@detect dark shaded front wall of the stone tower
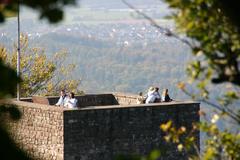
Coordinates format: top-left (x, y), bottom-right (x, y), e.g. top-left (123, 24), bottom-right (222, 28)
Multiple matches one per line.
top-left (64, 103), bottom-right (199, 160)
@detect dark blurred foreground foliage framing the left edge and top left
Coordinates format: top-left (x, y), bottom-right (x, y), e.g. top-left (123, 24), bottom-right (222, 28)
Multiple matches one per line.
top-left (0, 0), bottom-right (75, 160)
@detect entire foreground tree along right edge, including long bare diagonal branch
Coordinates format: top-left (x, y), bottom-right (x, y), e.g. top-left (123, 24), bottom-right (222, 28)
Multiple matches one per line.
top-left (122, 0), bottom-right (240, 160)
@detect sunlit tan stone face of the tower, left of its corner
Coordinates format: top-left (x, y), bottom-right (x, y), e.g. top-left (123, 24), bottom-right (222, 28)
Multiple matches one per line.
top-left (4, 101), bottom-right (63, 160)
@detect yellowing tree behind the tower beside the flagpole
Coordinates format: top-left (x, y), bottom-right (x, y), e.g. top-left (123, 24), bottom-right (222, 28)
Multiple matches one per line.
top-left (0, 35), bottom-right (80, 97)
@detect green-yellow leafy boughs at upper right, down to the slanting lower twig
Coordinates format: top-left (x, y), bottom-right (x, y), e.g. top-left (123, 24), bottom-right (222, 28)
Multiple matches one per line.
top-left (162, 0), bottom-right (240, 123)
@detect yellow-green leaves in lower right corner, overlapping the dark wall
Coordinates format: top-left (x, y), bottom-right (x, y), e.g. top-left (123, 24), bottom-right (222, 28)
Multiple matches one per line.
top-left (158, 112), bottom-right (240, 160)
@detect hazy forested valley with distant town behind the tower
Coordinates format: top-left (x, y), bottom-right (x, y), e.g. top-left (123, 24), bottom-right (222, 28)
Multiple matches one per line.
top-left (0, 0), bottom-right (191, 98)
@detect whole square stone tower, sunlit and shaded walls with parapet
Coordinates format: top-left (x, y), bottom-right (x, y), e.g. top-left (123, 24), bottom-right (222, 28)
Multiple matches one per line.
top-left (3, 93), bottom-right (199, 160)
